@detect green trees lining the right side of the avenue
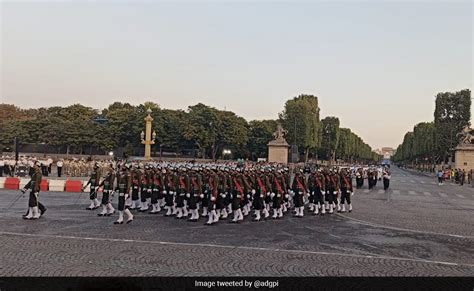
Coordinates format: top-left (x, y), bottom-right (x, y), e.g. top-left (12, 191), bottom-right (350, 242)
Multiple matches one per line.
top-left (393, 89), bottom-right (471, 165)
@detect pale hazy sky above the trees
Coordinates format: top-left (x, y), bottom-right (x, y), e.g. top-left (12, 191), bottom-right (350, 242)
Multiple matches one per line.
top-left (0, 1), bottom-right (474, 149)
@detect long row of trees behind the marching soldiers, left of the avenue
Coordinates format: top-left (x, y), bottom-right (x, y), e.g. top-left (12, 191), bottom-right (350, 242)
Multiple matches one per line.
top-left (0, 95), bottom-right (380, 162)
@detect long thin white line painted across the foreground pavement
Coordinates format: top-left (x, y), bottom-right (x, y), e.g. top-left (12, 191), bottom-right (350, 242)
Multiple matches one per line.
top-left (0, 233), bottom-right (474, 267)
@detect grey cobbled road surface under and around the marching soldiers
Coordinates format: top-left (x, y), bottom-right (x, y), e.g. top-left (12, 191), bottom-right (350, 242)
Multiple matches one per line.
top-left (0, 168), bottom-right (474, 276)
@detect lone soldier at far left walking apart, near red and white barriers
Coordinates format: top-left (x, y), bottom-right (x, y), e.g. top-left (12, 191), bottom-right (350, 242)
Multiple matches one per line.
top-left (21, 162), bottom-right (46, 220)
